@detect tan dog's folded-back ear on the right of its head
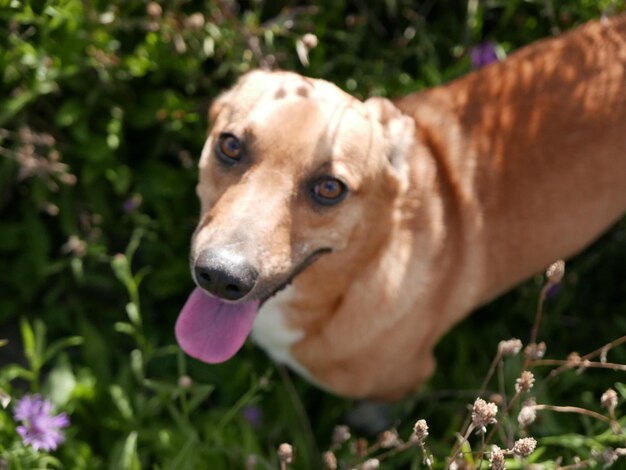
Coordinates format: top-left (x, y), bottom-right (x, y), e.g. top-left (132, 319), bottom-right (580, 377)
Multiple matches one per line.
top-left (365, 98), bottom-right (415, 171)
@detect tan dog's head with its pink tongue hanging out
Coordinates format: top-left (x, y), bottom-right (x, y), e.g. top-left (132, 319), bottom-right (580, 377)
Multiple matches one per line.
top-left (176, 71), bottom-right (414, 362)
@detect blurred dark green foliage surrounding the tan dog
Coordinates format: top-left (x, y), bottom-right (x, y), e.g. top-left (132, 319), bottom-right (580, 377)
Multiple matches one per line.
top-left (0, 0), bottom-right (626, 469)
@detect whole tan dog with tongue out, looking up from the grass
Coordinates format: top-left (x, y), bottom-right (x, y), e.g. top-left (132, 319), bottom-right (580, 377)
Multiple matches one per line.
top-left (176, 16), bottom-right (626, 398)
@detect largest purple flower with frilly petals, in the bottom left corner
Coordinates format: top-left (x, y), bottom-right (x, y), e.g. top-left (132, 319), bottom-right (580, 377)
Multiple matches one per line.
top-left (13, 394), bottom-right (70, 451)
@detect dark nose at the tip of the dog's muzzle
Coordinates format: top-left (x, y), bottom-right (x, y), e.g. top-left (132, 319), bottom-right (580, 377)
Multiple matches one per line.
top-left (194, 250), bottom-right (259, 300)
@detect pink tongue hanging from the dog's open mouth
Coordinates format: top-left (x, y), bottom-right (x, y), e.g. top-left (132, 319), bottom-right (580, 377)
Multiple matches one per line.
top-left (176, 287), bottom-right (259, 364)
